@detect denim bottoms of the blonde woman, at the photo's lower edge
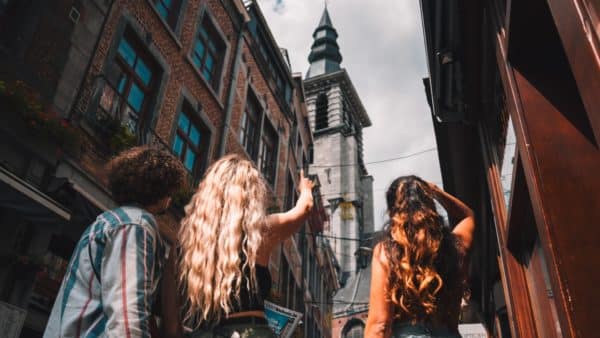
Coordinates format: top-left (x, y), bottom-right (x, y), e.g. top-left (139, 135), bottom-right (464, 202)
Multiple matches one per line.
top-left (189, 320), bottom-right (276, 338)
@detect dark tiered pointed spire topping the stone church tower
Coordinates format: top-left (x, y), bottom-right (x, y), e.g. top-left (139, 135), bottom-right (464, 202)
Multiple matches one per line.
top-left (306, 3), bottom-right (342, 78)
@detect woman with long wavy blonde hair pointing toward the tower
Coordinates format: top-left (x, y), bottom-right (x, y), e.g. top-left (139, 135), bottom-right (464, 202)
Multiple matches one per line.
top-left (178, 155), bottom-right (313, 337)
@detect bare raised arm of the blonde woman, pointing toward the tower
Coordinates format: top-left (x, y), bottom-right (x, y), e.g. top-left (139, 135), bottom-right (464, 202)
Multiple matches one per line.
top-left (267, 170), bottom-right (314, 244)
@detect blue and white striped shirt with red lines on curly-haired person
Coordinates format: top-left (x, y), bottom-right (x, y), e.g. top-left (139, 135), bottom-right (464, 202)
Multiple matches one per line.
top-left (44, 206), bottom-right (168, 338)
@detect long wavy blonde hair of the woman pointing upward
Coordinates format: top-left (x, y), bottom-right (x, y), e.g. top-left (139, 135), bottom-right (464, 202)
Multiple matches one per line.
top-left (179, 155), bottom-right (267, 328)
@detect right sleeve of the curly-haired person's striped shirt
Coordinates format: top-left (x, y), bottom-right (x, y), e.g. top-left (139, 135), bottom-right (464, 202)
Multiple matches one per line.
top-left (101, 224), bottom-right (160, 337)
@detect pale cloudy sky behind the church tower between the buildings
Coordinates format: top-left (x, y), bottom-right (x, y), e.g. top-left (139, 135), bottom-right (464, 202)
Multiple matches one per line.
top-left (258, 0), bottom-right (441, 229)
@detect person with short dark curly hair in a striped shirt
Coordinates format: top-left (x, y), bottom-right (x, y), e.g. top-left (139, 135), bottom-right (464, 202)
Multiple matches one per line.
top-left (44, 147), bottom-right (185, 337)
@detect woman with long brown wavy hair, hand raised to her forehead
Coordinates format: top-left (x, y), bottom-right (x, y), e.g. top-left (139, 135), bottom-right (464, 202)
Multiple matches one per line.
top-left (365, 176), bottom-right (475, 338)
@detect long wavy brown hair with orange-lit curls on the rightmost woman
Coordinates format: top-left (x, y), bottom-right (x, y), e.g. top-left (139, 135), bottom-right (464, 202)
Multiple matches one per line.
top-left (383, 176), bottom-right (461, 322)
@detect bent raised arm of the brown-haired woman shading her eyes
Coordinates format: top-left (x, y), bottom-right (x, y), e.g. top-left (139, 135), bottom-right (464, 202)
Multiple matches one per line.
top-left (429, 183), bottom-right (475, 251)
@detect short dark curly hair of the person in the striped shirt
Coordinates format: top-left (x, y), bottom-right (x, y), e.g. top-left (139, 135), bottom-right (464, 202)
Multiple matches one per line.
top-left (107, 146), bottom-right (186, 206)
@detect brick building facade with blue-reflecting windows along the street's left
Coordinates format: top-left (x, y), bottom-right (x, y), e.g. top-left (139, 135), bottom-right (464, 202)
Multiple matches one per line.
top-left (0, 0), bottom-right (336, 337)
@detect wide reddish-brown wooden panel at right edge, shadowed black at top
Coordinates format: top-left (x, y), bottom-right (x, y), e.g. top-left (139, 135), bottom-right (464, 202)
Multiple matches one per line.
top-left (508, 0), bottom-right (600, 337)
